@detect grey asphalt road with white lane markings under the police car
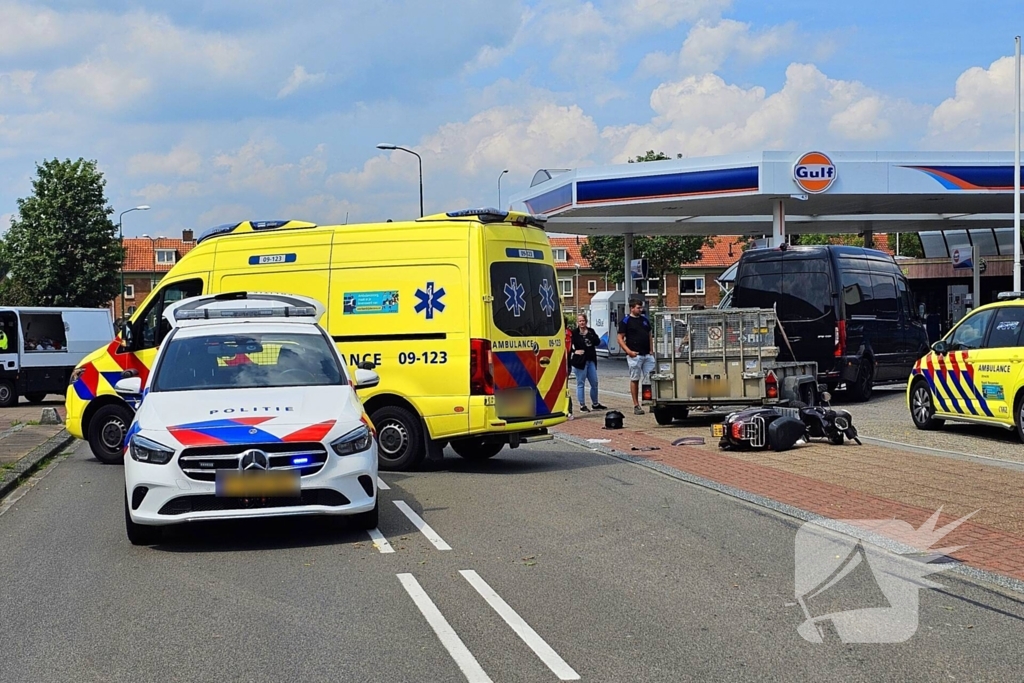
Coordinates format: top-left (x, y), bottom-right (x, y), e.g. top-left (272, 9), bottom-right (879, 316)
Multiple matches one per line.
top-left (0, 441), bottom-right (1024, 683)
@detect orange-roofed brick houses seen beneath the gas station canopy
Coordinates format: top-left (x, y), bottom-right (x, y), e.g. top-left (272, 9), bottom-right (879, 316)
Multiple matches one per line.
top-left (549, 237), bottom-right (743, 311)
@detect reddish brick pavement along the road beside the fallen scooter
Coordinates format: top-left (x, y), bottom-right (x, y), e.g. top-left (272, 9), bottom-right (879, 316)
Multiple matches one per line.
top-left (556, 383), bottom-right (1024, 580)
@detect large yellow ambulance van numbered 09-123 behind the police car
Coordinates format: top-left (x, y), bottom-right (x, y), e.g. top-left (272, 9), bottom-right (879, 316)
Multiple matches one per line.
top-left (67, 209), bottom-right (568, 470)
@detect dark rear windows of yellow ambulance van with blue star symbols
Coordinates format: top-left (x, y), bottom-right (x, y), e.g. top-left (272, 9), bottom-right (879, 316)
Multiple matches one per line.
top-left (490, 261), bottom-right (562, 337)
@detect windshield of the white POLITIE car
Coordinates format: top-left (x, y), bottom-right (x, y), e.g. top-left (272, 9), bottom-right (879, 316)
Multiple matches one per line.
top-left (151, 332), bottom-right (347, 391)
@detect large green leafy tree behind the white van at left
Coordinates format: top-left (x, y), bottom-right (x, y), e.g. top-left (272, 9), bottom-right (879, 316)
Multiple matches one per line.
top-left (0, 159), bottom-right (123, 307)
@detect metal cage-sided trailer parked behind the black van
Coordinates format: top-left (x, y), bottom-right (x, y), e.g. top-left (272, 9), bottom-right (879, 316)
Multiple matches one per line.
top-left (650, 308), bottom-right (817, 425)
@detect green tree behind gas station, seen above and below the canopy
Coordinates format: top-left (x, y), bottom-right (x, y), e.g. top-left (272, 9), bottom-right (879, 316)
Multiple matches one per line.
top-left (580, 150), bottom-right (712, 306)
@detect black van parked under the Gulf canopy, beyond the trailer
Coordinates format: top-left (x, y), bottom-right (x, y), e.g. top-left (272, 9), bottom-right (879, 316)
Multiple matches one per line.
top-left (731, 245), bottom-right (928, 400)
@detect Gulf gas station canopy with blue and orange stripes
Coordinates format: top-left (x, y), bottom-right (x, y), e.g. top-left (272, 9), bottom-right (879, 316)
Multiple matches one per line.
top-left (510, 152), bottom-right (1014, 240)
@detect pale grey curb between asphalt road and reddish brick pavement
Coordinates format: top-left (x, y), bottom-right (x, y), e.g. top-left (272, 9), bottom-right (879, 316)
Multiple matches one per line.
top-left (552, 431), bottom-right (1024, 594)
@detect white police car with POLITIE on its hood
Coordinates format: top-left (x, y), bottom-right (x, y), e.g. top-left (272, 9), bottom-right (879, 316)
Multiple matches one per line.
top-left (116, 293), bottom-right (380, 545)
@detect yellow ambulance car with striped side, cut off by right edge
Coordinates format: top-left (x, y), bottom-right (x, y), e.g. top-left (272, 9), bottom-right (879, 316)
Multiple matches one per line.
top-left (906, 292), bottom-right (1024, 440)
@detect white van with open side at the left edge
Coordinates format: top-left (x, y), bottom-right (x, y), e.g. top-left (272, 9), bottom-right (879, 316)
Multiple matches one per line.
top-left (0, 307), bottom-right (114, 408)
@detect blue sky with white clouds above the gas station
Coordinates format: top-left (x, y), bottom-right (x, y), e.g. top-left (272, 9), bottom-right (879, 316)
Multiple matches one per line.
top-left (0, 0), bottom-right (1024, 236)
